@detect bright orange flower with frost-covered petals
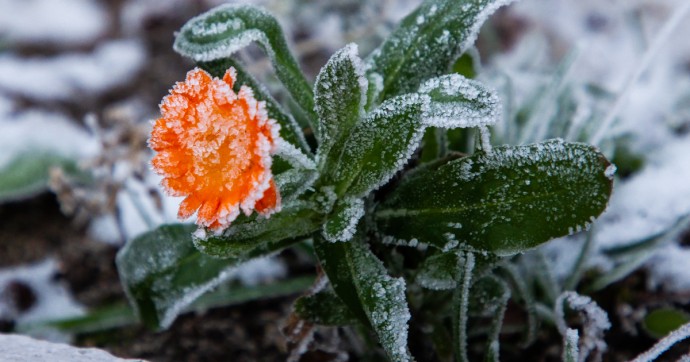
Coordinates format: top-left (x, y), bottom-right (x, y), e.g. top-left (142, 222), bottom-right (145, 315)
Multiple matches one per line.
top-left (149, 68), bottom-right (280, 230)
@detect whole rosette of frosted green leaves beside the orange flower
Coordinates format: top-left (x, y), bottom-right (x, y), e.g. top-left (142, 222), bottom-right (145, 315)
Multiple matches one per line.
top-left (117, 0), bottom-right (612, 361)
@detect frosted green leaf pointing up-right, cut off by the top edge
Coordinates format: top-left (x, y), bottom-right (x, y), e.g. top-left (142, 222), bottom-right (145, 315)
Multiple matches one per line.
top-left (367, 0), bottom-right (512, 101)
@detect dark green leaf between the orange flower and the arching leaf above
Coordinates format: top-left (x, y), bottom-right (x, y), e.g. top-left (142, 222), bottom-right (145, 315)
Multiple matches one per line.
top-left (198, 58), bottom-right (310, 154)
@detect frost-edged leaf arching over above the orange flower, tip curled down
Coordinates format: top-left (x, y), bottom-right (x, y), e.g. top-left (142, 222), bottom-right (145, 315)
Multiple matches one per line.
top-left (173, 4), bottom-right (316, 126)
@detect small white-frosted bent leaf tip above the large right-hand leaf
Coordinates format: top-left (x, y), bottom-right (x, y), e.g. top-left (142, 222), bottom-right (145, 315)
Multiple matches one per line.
top-left (418, 74), bottom-right (501, 128)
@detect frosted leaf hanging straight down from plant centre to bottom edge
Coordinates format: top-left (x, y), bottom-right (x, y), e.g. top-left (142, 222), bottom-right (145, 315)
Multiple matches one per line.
top-left (314, 236), bottom-right (412, 362)
